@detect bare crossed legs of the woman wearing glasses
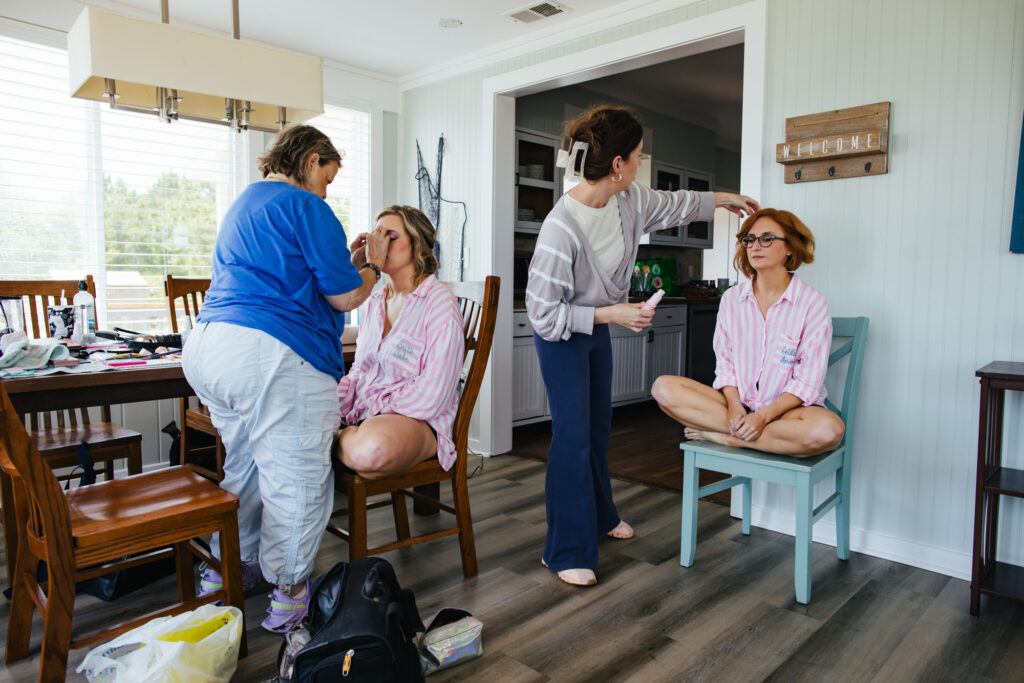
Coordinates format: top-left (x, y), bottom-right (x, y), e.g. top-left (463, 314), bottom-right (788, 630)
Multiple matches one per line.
top-left (651, 375), bottom-right (846, 458)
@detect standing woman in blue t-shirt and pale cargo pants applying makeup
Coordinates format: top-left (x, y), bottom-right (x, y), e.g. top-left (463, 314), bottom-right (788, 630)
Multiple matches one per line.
top-left (182, 126), bottom-right (388, 633)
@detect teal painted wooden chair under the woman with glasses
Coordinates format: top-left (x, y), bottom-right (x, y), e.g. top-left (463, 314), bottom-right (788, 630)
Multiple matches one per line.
top-left (679, 317), bottom-right (867, 604)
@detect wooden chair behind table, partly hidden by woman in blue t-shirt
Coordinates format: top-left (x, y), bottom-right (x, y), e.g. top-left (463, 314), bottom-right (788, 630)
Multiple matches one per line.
top-left (164, 275), bottom-right (224, 482)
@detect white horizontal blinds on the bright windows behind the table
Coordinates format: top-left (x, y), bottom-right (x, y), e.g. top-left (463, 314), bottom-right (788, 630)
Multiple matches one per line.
top-left (0, 35), bottom-right (371, 332)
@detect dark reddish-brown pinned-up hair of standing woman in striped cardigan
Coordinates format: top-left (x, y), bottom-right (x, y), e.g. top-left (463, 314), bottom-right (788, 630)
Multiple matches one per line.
top-left (565, 104), bottom-right (643, 180)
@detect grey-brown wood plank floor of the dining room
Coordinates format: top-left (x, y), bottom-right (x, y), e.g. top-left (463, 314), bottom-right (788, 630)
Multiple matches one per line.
top-left (0, 456), bottom-right (1024, 683)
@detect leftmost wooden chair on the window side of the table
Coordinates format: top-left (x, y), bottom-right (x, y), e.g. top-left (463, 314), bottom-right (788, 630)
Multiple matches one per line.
top-left (0, 275), bottom-right (142, 480)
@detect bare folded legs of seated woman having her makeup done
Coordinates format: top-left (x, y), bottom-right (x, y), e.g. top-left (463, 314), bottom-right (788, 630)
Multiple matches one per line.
top-left (336, 415), bottom-right (437, 479)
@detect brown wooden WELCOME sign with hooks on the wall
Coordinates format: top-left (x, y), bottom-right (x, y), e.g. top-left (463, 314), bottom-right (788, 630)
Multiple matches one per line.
top-left (775, 102), bottom-right (889, 184)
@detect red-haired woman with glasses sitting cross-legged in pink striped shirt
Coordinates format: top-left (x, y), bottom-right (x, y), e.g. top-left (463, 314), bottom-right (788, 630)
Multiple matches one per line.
top-left (651, 209), bottom-right (846, 456)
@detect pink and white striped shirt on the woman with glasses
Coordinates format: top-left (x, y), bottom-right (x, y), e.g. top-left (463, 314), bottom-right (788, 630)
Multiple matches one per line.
top-left (714, 274), bottom-right (831, 411)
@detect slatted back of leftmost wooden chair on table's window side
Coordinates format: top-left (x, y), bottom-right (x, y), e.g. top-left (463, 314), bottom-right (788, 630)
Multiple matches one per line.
top-left (0, 275), bottom-right (111, 431)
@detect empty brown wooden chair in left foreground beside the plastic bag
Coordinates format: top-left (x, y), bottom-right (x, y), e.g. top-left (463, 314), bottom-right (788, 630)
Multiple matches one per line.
top-left (0, 383), bottom-right (246, 681)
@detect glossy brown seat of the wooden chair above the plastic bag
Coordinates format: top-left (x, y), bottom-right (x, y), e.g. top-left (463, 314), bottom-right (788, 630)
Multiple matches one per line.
top-left (67, 467), bottom-right (239, 547)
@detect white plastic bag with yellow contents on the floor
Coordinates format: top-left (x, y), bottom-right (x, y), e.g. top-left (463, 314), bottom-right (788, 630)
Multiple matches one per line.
top-left (77, 605), bottom-right (242, 683)
